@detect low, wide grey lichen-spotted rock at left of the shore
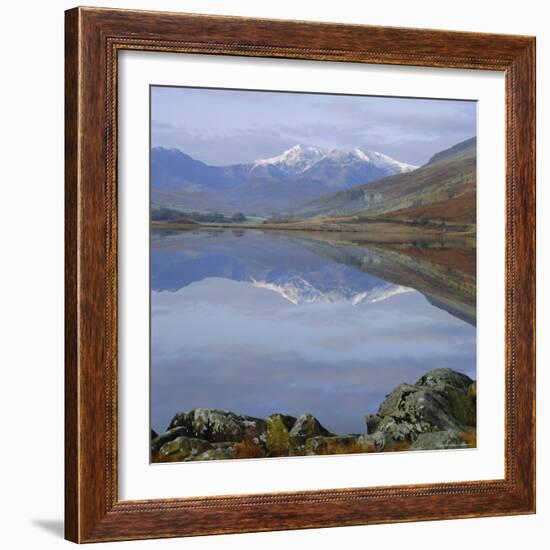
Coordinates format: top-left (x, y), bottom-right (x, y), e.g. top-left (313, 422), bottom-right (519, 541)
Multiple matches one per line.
top-left (170, 408), bottom-right (266, 443)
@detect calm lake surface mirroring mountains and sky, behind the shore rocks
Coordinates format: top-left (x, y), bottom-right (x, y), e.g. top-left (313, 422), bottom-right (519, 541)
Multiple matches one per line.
top-left (151, 230), bottom-right (476, 433)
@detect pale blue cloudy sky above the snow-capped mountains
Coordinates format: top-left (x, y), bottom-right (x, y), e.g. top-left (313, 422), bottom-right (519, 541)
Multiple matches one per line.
top-left (151, 86), bottom-right (477, 166)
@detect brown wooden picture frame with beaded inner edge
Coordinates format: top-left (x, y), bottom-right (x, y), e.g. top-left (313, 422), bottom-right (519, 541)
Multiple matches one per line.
top-left (65, 8), bottom-right (535, 543)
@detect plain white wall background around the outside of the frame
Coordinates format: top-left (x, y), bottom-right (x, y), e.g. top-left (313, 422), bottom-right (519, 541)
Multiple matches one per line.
top-left (0, 0), bottom-right (550, 550)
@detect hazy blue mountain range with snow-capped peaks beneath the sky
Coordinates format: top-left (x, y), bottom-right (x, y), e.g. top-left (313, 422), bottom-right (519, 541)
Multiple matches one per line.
top-left (151, 144), bottom-right (417, 215)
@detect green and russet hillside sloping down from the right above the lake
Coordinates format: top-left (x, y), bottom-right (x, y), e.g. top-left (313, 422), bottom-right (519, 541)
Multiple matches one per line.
top-left (288, 138), bottom-right (476, 224)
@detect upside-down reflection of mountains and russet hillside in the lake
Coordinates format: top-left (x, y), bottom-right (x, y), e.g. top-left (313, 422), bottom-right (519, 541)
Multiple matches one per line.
top-left (151, 230), bottom-right (476, 325)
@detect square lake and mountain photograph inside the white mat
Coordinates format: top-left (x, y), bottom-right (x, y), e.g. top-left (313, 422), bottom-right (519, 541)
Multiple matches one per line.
top-left (149, 85), bottom-right (477, 463)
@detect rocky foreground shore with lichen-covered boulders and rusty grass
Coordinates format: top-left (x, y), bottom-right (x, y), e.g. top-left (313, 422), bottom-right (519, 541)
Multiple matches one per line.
top-left (151, 369), bottom-right (477, 461)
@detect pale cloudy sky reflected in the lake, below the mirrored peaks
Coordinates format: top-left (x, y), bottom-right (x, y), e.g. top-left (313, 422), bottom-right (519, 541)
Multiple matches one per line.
top-left (151, 279), bottom-right (475, 433)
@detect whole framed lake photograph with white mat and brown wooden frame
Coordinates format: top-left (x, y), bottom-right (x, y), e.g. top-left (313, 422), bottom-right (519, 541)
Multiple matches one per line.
top-left (65, 8), bottom-right (535, 542)
